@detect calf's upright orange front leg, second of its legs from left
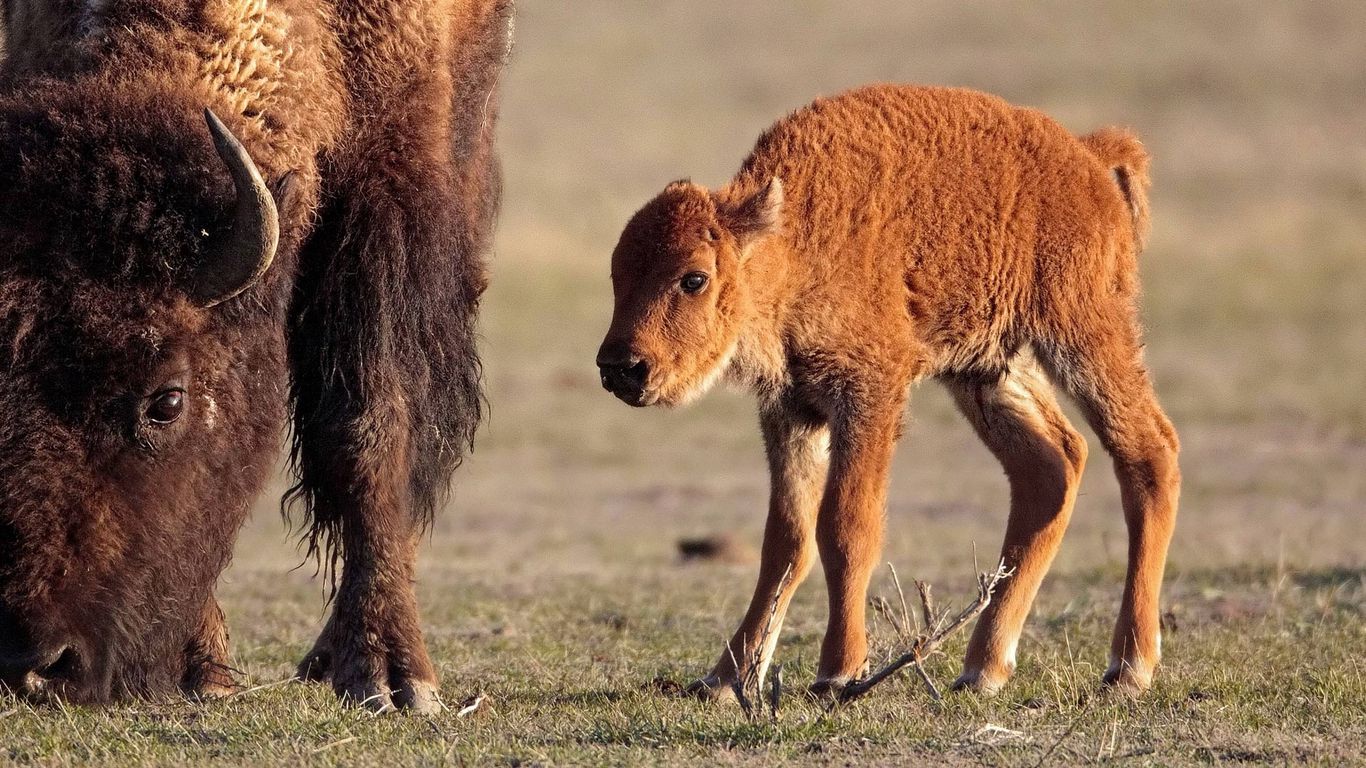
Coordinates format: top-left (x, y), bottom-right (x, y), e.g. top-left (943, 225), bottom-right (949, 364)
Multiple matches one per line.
top-left (811, 385), bottom-right (906, 696)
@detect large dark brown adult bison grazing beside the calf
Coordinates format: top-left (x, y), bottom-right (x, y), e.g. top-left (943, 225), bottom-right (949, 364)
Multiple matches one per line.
top-left (0, 0), bottom-right (511, 709)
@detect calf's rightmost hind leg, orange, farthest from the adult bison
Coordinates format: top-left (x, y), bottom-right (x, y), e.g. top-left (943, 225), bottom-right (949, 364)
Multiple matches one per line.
top-left (1045, 306), bottom-right (1180, 691)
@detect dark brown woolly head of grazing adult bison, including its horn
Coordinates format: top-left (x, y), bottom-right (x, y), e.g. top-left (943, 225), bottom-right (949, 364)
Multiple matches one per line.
top-left (0, 101), bottom-right (296, 701)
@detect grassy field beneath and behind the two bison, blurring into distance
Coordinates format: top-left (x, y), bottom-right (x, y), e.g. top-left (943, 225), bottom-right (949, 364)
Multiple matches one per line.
top-left (0, 0), bottom-right (1366, 765)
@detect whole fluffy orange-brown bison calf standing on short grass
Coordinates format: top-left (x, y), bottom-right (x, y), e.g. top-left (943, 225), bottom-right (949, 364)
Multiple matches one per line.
top-left (597, 86), bottom-right (1179, 691)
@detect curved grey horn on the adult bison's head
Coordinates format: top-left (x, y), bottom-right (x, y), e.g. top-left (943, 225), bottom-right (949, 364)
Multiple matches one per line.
top-left (187, 109), bottom-right (288, 307)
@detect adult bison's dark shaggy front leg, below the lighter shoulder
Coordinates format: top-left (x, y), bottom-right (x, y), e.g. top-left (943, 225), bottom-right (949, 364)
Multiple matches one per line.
top-left (290, 162), bottom-right (493, 711)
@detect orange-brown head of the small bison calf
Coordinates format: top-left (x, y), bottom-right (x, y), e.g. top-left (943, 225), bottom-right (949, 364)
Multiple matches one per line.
top-left (597, 178), bottom-right (783, 406)
